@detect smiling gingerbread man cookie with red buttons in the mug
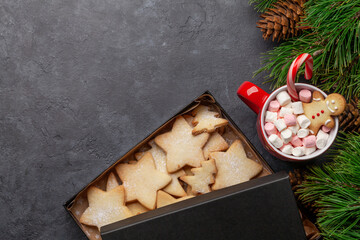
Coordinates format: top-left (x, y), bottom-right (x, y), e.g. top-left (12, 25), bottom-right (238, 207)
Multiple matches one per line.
top-left (303, 91), bottom-right (346, 135)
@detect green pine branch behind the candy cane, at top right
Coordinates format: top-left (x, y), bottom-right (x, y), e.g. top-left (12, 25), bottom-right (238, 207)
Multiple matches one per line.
top-left (255, 0), bottom-right (360, 99)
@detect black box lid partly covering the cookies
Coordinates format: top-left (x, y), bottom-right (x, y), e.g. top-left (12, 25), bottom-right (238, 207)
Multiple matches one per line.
top-left (101, 172), bottom-right (306, 240)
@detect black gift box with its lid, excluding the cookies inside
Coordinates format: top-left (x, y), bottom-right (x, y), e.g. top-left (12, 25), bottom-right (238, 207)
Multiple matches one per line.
top-left (64, 91), bottom-right (306, 240)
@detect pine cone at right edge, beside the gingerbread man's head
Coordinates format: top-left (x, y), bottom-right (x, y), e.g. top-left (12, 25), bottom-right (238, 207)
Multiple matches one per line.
top-left (339, 97), bottom-right (360, 133)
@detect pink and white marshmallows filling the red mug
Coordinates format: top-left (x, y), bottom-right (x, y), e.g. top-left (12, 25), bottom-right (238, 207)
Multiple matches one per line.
top-left (264, 89), bottom-right (331, 157)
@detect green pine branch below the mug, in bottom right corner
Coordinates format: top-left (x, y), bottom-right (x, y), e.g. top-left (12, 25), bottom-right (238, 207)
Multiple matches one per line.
top-left (297, 133), bottom-right (360, 240)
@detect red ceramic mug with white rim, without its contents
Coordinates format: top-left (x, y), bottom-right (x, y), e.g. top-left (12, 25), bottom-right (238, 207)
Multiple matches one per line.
top-left (237, 81), bottom-right (339, 162)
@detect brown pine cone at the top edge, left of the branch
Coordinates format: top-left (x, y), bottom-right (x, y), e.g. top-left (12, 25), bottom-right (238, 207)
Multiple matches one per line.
top-left (256, 0), bottom-right (306, 41)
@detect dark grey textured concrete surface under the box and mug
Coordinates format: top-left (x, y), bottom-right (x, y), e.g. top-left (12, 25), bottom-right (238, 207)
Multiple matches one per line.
top-left (0, 0), bottom-right (310, 239)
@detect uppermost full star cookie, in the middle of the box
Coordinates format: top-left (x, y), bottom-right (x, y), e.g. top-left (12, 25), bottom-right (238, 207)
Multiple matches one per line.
top-left (155, 116), bottom-right (209, 173)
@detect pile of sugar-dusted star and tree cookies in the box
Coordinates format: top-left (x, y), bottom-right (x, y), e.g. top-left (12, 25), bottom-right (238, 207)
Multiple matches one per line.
top-left (80, 105), bottom-right (262, 229)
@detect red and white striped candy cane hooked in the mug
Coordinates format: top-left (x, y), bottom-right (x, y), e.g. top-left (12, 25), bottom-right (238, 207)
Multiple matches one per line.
top-left (287, 53), bottom-right (313, 101)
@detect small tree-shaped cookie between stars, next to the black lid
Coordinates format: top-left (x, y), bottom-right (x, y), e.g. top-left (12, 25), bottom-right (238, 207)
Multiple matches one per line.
top-left (180, 159), bottom-right (216, 194)
